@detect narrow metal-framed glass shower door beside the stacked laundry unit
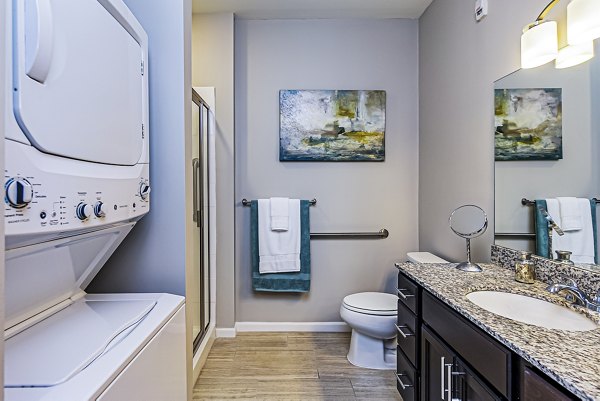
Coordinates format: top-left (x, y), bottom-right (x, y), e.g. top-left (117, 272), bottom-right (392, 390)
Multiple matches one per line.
top-left (193, 90), bottom-right (210, 351)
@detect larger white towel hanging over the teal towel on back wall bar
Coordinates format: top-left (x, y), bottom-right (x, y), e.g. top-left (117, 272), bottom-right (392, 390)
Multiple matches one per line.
top-left (258, 199), bottom-right (300, 274)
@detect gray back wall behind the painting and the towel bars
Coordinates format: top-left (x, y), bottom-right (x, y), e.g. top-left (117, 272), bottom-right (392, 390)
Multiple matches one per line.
top-left (235, 20), bottom-right (419, 322)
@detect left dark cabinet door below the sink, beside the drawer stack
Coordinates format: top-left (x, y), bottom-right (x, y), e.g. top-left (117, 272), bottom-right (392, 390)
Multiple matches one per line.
top-left (421, 326), bottom-right (455, 401)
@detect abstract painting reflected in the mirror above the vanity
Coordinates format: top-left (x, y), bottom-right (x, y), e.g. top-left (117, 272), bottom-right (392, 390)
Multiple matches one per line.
top-left (494, 88), bottom-right (562, 161)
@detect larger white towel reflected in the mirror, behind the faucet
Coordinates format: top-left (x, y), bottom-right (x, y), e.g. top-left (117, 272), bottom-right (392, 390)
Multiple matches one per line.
top-left (546, 198), bottom-right (594, 263)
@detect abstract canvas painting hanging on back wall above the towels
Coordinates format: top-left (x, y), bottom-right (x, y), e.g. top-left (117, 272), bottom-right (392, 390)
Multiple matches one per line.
top-left (279, 90), bottom-right (386, 161)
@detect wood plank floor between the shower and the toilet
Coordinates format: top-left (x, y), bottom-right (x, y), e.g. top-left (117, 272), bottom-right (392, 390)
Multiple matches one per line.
top-left (193, 333), bottom-right (402, 401)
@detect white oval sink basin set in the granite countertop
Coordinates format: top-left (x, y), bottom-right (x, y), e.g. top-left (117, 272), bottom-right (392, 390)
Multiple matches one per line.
top-left (467, 291), bottom-right (600, 331)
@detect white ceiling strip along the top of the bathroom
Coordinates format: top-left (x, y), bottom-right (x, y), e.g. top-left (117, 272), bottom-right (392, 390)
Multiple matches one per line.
top-left (192, 0), bottom-right (432, 19)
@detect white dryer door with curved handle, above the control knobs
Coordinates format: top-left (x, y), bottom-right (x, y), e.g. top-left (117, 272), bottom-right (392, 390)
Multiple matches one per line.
top-left (13, 0), bottom-right (147, 165)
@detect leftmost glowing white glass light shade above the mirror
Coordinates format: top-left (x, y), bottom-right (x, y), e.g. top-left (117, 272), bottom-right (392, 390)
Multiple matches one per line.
top-left (521, 21), bottom-right (558, 68)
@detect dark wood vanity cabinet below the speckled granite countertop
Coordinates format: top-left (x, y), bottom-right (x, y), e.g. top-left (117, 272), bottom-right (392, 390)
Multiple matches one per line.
top-left (397, 272), bottom-right (576, 401)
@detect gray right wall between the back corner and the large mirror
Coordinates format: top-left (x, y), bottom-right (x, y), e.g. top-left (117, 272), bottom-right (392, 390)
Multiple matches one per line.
top-left (419, 0), bottom-right (567, 261)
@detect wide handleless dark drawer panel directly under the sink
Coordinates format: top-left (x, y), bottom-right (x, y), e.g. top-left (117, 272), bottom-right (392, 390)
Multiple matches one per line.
top-left (423, 291), bottom-right (511, 398)
